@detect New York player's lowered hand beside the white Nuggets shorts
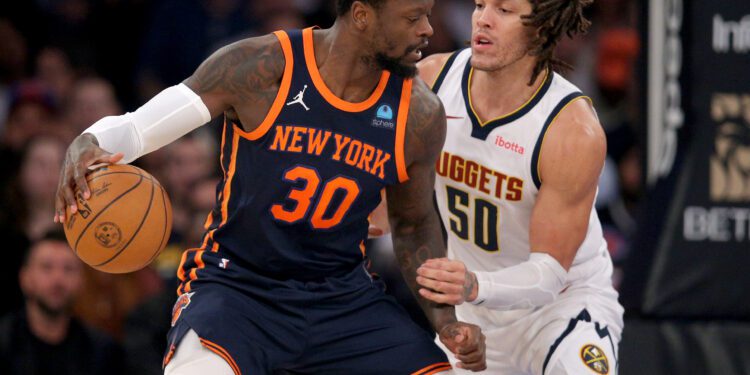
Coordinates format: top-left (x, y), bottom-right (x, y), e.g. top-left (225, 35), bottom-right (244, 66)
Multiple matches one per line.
top-left (439, 322), bottom-right (487, 371)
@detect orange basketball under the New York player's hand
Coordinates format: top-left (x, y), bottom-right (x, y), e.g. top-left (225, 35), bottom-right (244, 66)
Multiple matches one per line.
top-left (65, 165), bottom-right (172, 273)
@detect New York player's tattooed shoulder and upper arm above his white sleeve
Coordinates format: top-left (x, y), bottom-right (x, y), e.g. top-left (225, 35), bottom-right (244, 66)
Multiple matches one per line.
top-left (183, 34), bottom-right (285, 131)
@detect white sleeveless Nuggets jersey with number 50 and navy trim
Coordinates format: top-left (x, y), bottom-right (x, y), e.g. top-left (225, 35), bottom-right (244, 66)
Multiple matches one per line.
top-left (433, 49), bottom-right (607, 290)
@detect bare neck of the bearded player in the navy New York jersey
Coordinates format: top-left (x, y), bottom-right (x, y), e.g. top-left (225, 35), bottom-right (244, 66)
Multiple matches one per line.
top-left (314, 21), bottom-right (383, 103)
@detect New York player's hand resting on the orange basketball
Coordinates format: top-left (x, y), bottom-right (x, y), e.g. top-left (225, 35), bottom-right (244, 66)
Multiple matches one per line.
top-left (54, 134), bottom-right (123, 223)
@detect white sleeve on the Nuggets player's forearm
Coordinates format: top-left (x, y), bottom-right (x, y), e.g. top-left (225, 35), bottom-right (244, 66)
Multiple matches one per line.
top-left (470, 253), bottom-right (567, 310)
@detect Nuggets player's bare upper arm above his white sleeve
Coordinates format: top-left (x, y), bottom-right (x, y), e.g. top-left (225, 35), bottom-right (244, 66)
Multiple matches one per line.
top-left (529, 98), bottom-right (606, 270)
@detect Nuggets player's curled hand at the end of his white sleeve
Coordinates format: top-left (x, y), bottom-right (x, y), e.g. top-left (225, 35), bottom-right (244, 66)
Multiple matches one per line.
top-left (417, 258), bottom-right (479, 305)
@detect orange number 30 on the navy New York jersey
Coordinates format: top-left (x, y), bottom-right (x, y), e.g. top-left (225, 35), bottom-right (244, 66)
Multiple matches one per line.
top-left (271, 166), bottom-right (359, 229)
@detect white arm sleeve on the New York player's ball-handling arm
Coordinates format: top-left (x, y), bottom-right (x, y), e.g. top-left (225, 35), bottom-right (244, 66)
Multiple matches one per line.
top-left (84, 83), bottom-right (211, 163)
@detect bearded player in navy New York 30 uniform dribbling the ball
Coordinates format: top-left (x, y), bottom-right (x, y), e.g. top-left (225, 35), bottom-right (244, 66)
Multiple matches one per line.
top-left (55, 0), bottom-right (485, 375)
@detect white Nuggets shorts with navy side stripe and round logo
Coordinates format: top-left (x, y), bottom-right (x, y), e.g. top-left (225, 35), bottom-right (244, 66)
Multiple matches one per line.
top-left (437, 262), bottom-right (624, 375)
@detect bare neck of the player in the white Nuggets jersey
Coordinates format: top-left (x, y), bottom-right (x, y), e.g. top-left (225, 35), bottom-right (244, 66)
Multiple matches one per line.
top-left (470, 57), bottom-right (546, 121)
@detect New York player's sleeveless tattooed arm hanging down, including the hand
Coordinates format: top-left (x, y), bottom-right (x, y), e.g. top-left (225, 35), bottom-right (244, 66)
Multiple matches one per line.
top-left (386, 79), bottom-right (486, 371)
